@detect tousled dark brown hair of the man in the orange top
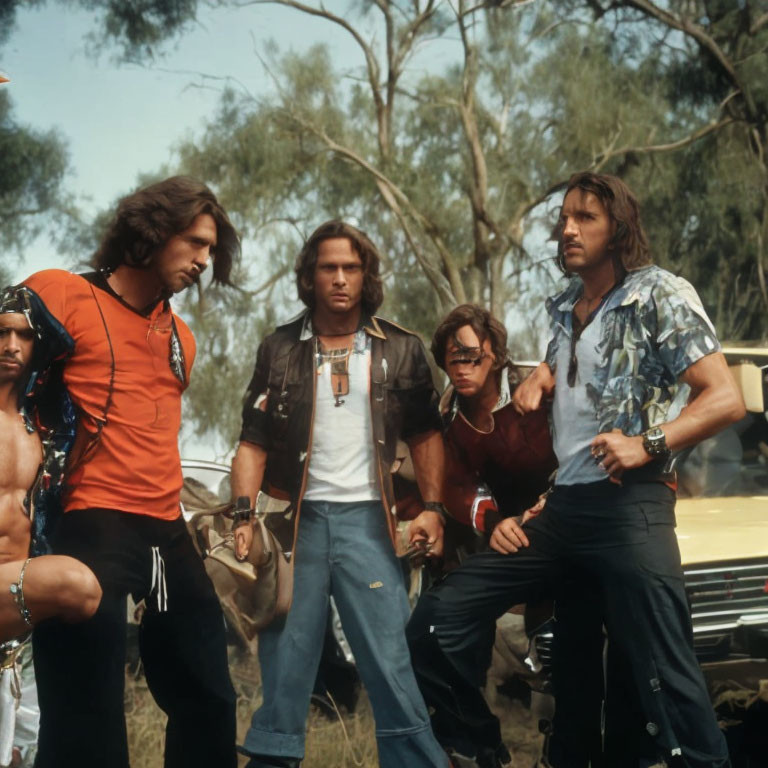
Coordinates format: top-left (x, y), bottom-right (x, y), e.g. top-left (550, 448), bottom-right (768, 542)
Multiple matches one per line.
top-left (93, 176), bottom-right (240, 285)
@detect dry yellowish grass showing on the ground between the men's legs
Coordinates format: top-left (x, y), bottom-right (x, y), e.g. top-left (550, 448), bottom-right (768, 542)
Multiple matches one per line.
top-left (125, 649), bottom-right (540, 768)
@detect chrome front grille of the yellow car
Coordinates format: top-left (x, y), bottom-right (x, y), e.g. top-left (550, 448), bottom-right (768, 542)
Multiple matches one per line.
top-left (685, 560), bottom-right (768, 659)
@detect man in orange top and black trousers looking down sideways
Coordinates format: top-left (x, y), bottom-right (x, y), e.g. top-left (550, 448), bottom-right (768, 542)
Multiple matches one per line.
top-left (26, 176), bottom-right (239, 768)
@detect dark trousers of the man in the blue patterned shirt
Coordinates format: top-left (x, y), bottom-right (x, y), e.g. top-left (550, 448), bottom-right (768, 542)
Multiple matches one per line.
top-left (408, 481), bottom-right (729, 768)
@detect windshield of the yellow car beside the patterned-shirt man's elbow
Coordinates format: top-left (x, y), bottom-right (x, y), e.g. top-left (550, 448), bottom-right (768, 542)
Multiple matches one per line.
top-left (675, 413), bottom-right (768, 498)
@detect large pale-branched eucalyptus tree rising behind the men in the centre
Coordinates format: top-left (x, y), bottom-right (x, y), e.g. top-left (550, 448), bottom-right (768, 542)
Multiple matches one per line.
top-left (176, 0), bottom-right (713, 325)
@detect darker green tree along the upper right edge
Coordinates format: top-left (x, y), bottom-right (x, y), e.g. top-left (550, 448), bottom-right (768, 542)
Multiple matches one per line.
top-left (565, 0), bottom-right (768, 338)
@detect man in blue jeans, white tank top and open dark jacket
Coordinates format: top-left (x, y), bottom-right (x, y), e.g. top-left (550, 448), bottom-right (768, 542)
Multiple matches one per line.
top-left (232, 221), bottom-right (447, 768)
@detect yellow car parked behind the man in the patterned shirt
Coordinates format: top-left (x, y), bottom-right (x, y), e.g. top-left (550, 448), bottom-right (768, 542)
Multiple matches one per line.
top-left (676, 343), bottom-right (768, 690)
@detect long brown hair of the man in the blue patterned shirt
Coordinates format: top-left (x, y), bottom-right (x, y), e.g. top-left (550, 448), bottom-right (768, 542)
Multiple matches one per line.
top-left (552, 171), bottom-right (653, 274)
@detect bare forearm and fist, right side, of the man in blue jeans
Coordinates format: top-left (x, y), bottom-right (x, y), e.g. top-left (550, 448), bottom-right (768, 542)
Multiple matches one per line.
top-left (408, 431), bottom-right (445, 556)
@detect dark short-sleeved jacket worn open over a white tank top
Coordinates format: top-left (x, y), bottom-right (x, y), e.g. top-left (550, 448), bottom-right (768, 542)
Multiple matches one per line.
top-left (240, 312), bottom-right (441, 540)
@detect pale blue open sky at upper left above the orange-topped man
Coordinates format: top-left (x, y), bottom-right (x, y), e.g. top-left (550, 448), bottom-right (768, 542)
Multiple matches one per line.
top-left (0, 0), bottom-right (380, 279)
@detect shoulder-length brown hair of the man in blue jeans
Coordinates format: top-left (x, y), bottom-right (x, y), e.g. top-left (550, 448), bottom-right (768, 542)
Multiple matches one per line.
top-left (294, 219), bottom-right (384, 315)
